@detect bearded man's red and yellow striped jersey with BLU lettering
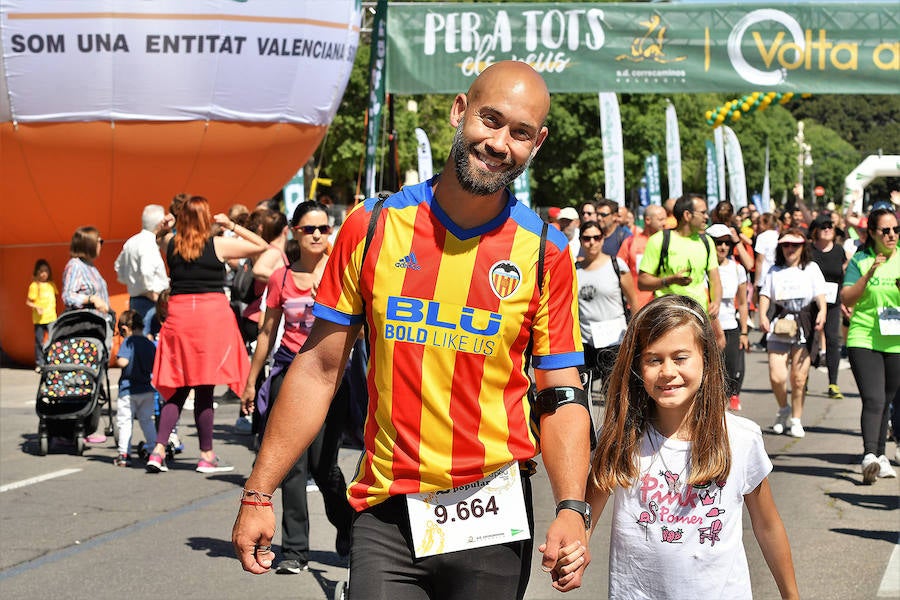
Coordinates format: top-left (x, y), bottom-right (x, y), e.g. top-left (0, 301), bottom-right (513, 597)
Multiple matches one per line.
top-left (313, 179), bottom-right (583, 510)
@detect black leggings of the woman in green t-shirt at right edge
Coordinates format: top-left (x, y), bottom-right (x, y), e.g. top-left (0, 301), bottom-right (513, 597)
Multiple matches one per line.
top-left (848, 348), bottom-right (900, 456)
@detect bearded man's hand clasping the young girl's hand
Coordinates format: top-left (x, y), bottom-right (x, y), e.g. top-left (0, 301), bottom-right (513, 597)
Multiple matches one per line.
top-left (538, 509), bottom-right (591, 592)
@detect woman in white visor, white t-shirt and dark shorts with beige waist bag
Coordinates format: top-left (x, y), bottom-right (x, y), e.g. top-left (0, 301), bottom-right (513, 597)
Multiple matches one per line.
top-left (759, 228), bottom-right (826, 438)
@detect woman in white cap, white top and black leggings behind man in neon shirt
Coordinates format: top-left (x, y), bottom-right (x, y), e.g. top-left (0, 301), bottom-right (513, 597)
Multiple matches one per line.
top-left (706, 223), bottom-right (750, 410)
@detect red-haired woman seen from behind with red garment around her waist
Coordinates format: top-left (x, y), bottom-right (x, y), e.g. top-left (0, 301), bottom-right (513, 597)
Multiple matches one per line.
top-left (147, 196), bottom-right (267, 473)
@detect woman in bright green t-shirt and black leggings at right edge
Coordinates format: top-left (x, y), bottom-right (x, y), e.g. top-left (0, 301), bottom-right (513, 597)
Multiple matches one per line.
top-left (841, 209), bottom-right (900, 484)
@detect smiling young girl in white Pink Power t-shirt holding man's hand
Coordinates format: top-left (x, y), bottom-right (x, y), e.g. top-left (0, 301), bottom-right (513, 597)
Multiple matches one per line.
top-left (557, 296), bottom-right (798, 600)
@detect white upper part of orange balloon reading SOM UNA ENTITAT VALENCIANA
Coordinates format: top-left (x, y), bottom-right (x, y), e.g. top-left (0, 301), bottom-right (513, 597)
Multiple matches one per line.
top-left (0, 0), bottom-right (361, 125)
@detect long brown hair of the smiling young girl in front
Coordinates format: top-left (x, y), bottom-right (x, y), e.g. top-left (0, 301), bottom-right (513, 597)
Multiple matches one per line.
top-left (590, 296), bottom-right (731, 492)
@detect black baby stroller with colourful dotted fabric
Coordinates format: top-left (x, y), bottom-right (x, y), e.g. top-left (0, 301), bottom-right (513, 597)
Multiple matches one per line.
top-left (35, 310), bottom-right (116, 456)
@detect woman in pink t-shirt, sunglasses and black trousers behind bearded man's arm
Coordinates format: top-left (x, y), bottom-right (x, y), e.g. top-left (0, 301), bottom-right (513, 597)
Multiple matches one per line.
top-left (241, 201), bottom-right (353, 574)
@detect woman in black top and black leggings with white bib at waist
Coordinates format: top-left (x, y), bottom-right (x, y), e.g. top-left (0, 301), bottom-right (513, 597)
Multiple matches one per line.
top-left (809, 213), bottom-right (847, 400)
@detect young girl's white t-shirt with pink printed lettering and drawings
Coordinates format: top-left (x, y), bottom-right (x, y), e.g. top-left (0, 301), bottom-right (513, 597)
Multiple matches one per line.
top-left (609, 414), bottom-right (772, 600)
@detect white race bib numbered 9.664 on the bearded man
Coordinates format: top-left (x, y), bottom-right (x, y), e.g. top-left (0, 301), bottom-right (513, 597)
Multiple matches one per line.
top-left (406, 461), bottom-right (531, 558)
